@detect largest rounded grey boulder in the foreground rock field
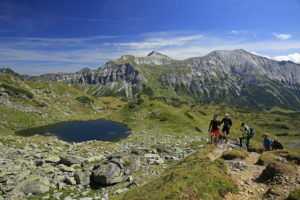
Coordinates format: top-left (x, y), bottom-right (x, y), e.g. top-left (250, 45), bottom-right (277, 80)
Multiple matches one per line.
top-left (92, 162), bottom-right (123, 185)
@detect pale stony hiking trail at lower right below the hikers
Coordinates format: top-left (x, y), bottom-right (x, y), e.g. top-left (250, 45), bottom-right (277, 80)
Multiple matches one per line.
top-left (207, 140), bottom-right (299, 200)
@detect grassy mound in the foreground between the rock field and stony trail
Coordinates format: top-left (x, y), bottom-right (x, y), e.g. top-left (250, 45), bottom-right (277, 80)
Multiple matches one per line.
top-left (113, 147), bottom-right (238, 200)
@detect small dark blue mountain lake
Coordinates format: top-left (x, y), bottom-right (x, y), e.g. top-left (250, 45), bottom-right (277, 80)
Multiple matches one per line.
top-left (16, 119), bottom-right (130, 142)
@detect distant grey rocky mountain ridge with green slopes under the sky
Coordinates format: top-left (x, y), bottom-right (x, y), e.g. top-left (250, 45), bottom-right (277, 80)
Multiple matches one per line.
top-left (0, 49), bottom-right (300, 110)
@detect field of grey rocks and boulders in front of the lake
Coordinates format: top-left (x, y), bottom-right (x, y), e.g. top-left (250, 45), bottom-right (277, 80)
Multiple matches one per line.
top-left (0, 132), bottom-right (203, 200)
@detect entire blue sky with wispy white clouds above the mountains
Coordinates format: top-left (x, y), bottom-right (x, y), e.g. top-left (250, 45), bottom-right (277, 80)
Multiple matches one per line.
top-left (0, 0), bottom-right (300, 75)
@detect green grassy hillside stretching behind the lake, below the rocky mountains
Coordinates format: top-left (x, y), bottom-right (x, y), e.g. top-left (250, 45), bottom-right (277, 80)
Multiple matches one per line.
top-left (0, 71), bottom-right (300, 147)
